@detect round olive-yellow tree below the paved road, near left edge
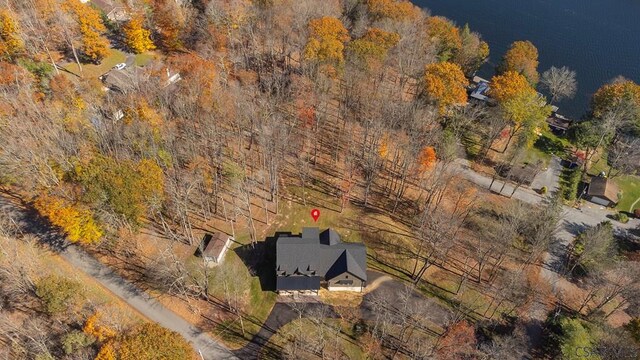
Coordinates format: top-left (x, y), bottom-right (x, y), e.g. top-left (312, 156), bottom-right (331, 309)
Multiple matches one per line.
top-left (36, 275), bottom-right (82, 315)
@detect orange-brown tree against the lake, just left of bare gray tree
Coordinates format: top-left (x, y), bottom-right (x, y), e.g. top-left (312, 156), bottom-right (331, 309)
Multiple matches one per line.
top-left (498, 41), bottom-right (540, 86)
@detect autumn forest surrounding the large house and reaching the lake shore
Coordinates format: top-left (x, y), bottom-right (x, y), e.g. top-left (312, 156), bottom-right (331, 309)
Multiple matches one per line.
top-left (0, 0), bottom-right (640, 360)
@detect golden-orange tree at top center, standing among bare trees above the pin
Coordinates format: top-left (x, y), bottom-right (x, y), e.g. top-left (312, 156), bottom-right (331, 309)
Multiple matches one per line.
top-left (304, 16), bottom-right (349, 64)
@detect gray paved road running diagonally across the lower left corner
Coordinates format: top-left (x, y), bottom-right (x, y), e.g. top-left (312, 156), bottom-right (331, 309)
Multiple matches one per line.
top-left (0, 194), bottom-right (237, 360)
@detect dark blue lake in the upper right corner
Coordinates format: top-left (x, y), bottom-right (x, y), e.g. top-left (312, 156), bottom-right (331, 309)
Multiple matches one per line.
top-left (413, 0), bottom-right (640, 118)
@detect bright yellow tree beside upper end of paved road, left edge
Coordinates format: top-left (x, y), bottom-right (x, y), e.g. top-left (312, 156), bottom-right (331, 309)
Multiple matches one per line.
top-left (34, 194), bottom-right (103, 244)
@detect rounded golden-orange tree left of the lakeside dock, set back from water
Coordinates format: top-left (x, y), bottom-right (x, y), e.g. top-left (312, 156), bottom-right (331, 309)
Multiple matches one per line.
top-left (424, 62), bottom-right (468, 114)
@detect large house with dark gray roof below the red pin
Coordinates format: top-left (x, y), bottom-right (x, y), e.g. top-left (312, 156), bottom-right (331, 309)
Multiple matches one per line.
top-left (276, 228), bottom-right (367, 294)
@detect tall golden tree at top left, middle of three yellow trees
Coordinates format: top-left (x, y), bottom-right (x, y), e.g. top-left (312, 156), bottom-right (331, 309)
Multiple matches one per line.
top-left (62, 0), bottom-right (109, 63)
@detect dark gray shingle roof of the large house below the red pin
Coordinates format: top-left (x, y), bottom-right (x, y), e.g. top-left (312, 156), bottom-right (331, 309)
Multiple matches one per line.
top-left (276, 228), bottom-right (367, 290)
